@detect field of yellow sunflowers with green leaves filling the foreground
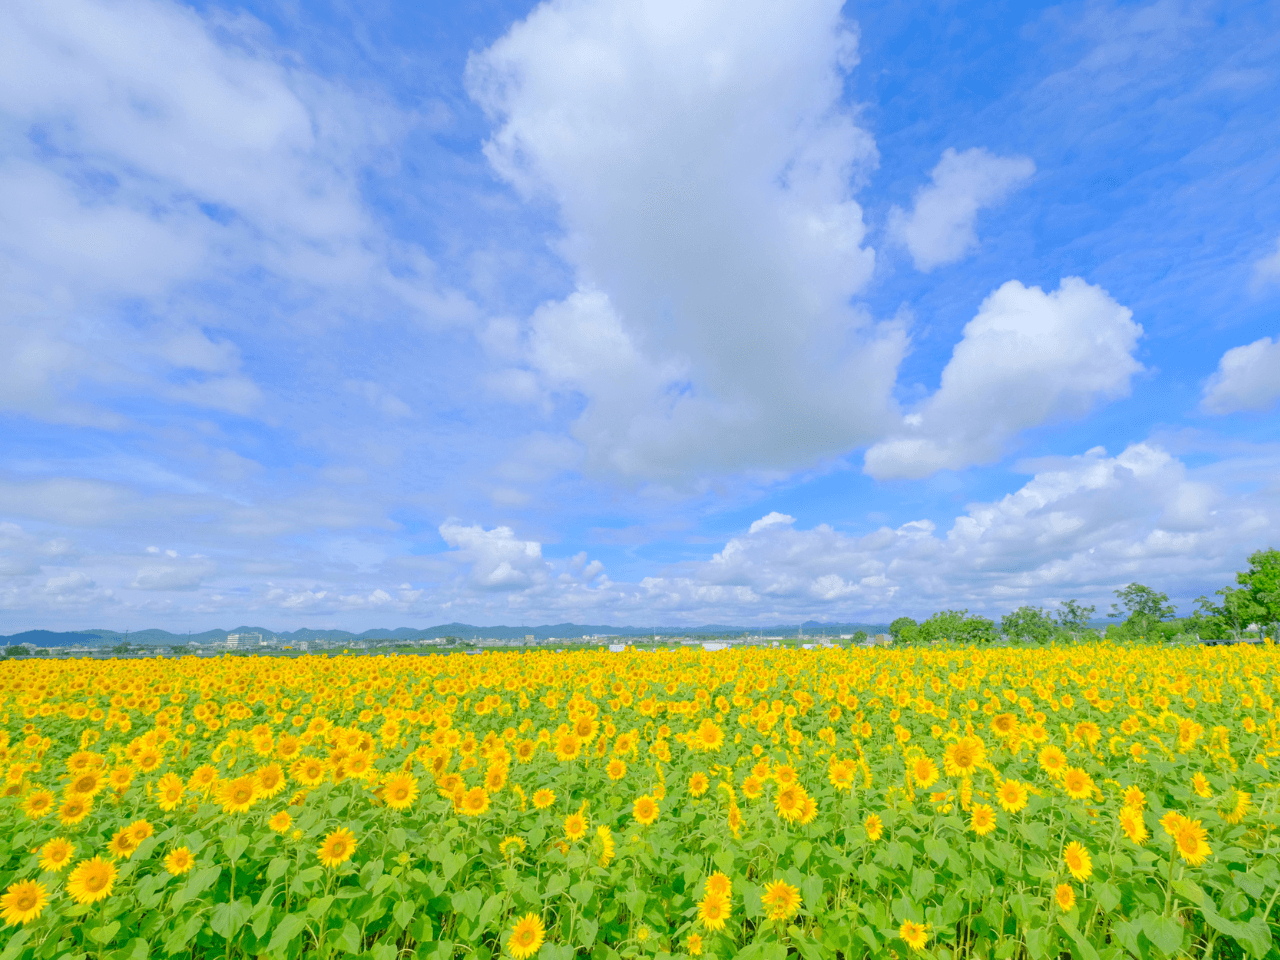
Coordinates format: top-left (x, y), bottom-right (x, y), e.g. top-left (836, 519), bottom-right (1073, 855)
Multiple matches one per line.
top-left (0, 643), bottom-right (1280, 960)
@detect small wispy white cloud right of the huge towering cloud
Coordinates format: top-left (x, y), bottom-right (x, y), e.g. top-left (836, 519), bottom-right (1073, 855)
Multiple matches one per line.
top-left (888, 147), bottom-right (1036, 273)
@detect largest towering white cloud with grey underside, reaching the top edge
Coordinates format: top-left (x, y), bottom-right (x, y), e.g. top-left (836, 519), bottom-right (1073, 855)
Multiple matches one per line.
top-left (467, 0), bottom-right (905, 483)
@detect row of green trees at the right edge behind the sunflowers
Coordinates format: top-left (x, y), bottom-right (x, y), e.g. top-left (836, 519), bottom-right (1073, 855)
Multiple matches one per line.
top-left (888, 549), bottom-right (1280, 644)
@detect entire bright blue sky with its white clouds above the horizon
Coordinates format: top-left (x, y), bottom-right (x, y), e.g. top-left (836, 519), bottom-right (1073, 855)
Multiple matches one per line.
top-left (0, 0), bottom-right (1280, 632)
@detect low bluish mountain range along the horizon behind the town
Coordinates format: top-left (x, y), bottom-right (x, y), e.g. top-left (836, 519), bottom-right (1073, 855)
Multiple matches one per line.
top-left (0, 620), bottom-right (888, 646)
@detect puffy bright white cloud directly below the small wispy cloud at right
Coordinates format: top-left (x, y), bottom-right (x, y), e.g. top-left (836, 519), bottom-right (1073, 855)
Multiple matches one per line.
top-left (864, 276), bottom-right (1143, 479)
